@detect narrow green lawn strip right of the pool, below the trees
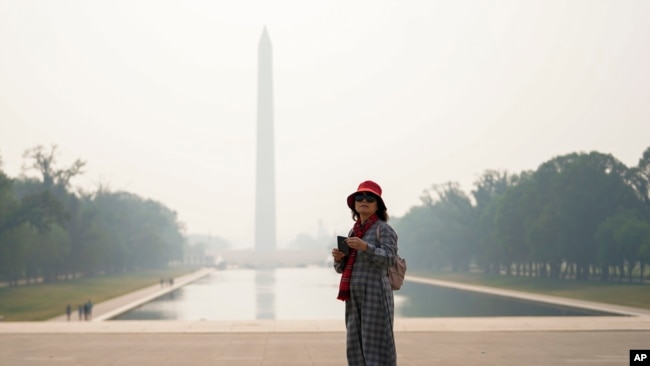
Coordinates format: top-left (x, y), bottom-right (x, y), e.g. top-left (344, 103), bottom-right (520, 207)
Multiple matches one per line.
top-left (416, 271), bottom-right (650, 309)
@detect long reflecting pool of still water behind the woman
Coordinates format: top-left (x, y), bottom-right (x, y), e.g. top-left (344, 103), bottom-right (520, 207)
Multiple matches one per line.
top-left (113, 267), bottom-right (616, 321)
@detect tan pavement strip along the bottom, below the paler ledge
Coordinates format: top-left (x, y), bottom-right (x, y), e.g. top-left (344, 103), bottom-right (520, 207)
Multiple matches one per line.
top-left (0, 331), bottom-right (650, 366)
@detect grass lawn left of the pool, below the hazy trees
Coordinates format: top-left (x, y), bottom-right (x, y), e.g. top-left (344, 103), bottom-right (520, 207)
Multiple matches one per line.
top-left (0, 267), bottom-right (195, 321)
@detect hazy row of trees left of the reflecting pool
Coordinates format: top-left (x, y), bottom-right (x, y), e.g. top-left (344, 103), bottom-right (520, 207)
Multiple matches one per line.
top-left (0, 146), bottom-right (185, 284)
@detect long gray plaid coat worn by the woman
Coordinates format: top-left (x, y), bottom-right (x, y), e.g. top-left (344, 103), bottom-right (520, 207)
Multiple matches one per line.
top-left (334, 220), bottom-right (397, 366)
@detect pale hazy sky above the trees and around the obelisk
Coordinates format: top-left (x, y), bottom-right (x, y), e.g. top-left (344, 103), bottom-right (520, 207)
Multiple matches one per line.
top-left (0, 0), bottom-right (650, 247)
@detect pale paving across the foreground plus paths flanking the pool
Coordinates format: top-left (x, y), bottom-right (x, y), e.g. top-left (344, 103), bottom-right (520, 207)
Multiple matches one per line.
top-left (0, 270), bottom-right (650, 366)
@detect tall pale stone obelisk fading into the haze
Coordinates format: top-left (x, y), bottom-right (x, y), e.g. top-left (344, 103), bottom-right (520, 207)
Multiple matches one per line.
top-left (255, 27), bottom-right (276, 252)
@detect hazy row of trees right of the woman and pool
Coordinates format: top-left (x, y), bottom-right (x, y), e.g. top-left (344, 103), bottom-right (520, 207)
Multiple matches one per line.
top-left (393, 148), bottom-right (650, 281)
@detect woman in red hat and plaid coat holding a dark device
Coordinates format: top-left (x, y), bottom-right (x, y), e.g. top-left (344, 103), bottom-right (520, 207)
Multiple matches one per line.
top-left (332, 180), bottom-right (397, 366)
